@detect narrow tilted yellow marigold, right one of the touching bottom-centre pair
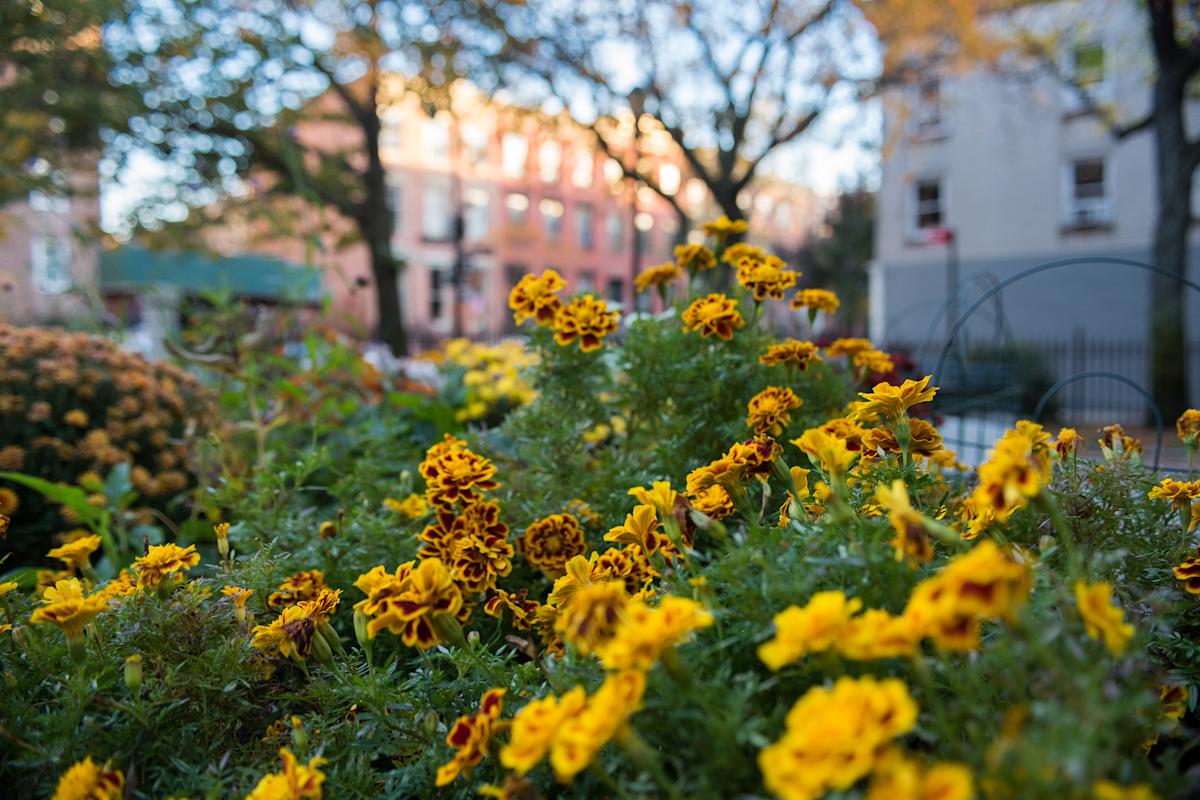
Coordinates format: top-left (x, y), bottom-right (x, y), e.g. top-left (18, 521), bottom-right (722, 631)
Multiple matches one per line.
top-left (550, 669), bottom-right (646, 783)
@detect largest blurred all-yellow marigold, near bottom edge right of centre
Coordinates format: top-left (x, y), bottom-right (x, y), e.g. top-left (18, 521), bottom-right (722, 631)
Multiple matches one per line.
top-left (758, 678), bottom-right (917, 800)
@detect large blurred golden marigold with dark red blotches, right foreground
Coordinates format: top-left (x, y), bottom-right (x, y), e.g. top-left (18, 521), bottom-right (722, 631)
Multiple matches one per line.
top-left (905, 541), bottom-right (1032, 650)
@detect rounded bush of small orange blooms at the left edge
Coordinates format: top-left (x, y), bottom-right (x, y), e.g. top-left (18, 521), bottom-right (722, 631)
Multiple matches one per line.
top-left (0, 325), bottom-right (212, 564)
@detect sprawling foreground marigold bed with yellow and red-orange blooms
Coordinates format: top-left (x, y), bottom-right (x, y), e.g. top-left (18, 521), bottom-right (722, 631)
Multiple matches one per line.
top-left (0, 219), bottom-right (1200, 800)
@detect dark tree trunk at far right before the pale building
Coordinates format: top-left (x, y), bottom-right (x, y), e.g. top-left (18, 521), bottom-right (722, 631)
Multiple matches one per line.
top-left (1151, 65), bottom-right (1194, 420)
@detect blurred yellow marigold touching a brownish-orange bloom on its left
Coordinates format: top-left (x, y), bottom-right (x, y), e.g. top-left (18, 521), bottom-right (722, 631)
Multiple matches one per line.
top-left (595, 596), bottom-right (713, 672)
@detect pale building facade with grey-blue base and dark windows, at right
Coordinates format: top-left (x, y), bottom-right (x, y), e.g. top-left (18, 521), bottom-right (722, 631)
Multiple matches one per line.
top-left (870, 0), bottom-right (1200, 352)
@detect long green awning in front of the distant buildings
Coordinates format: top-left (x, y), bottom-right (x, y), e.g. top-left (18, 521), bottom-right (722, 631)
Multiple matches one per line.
top-left (100, 246), bottom-right (322, 302)
